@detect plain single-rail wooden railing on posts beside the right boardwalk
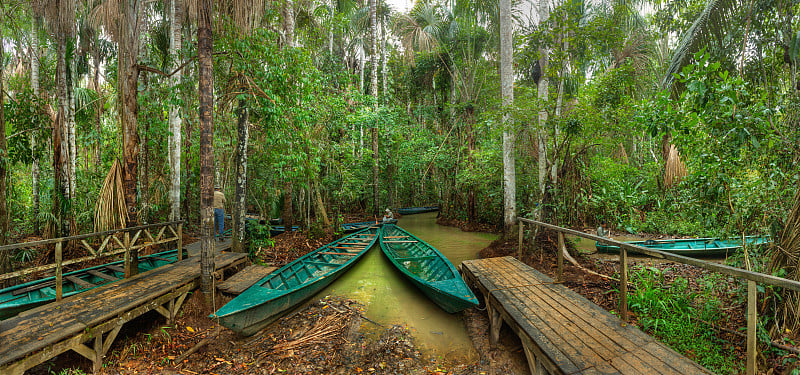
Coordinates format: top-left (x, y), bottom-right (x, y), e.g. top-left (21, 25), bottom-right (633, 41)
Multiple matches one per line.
top-left (518, 218), bottom-right (800, 374)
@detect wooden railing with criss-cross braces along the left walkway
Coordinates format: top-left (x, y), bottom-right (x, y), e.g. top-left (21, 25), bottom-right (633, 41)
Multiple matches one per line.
top-left (0, 220), bottom-right (183, 301)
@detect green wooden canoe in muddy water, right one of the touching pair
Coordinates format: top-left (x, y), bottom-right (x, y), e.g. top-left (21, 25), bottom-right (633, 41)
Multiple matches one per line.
top-left (379, 224), bottom-right (478, 313)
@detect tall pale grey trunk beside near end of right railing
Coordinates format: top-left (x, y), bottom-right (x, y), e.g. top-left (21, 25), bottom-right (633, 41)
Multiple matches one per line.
top-left (500, 0), bottom-right (517, 231)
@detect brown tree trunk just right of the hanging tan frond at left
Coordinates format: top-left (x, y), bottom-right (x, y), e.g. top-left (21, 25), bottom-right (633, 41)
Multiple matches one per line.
top-left (117, 0), bottom-right (139, 275)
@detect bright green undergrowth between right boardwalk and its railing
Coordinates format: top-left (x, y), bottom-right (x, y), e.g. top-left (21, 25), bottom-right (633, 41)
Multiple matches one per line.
top-left (628, 267), bottom-right (744, 374)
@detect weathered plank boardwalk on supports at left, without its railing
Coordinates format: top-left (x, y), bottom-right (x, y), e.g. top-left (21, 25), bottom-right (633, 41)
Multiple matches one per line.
top-left (0, 241), bottom-right (247, 375)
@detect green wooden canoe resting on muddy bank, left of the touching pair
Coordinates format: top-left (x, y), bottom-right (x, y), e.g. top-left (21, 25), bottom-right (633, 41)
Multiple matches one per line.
top-left (211, 227), bottom-right (380, 336)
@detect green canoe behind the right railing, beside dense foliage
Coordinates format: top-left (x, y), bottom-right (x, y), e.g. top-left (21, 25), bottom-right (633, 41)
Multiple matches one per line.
top-left (595, 236), bottom-right (771, 256)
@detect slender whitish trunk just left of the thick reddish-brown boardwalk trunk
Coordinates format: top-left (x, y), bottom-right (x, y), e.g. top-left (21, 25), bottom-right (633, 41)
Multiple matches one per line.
top-left (169, 0), bottom-right (181, 220)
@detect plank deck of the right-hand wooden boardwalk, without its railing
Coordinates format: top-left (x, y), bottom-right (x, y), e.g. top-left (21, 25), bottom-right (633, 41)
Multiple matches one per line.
top-left (461, 257), bottom-right (711, 374)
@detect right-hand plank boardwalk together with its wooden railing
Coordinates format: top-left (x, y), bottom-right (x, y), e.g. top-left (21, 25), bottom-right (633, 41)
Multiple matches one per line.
top-left (490, 218), bottom-right (800, 375)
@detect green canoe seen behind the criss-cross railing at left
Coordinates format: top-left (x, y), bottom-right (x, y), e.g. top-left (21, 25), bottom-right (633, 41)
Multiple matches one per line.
top-left (0, 250), bottom-right (185, 320)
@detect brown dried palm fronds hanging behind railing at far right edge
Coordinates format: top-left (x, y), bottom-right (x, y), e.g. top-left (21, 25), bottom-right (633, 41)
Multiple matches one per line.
top-left (769, 186), bottom-right (800, 334)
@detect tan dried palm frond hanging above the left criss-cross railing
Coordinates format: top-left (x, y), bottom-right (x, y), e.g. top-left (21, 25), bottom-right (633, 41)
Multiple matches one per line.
top-left (94, 159), bottom-right (128, 232)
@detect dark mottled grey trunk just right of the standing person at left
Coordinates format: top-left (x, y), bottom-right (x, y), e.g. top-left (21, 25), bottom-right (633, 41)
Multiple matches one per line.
top-left (233, 99), bottom-right (250, 252)
